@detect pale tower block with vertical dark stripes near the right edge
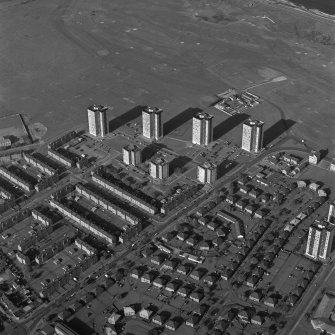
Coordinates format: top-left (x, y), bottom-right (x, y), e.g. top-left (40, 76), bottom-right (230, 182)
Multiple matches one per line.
top-left (305, 220), bottom-right (335, 261)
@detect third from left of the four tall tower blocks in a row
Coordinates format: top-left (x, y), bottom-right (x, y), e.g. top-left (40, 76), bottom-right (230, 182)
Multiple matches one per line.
top-left (192, 112), bottom-right (213, 145)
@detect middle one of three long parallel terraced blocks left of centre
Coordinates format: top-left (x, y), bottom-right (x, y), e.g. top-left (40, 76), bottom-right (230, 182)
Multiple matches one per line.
top-left (76, 184), bottom-right (141, 226)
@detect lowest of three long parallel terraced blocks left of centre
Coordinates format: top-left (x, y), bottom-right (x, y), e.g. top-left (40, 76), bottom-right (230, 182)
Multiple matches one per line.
top-left (49, 199), bottom-right (118, 244)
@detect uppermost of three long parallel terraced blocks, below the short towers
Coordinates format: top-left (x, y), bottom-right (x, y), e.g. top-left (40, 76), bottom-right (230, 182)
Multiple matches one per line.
top-left (92, 173), bottom-right (158, 214)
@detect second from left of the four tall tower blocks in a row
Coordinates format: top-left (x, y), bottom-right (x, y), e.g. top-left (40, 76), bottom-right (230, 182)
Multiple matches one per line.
top-left (142, 107), bottom-right (163, 141)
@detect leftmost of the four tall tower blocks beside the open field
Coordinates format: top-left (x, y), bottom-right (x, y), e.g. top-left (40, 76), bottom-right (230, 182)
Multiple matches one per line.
top-left (87, 105), bottom-right (108, 137)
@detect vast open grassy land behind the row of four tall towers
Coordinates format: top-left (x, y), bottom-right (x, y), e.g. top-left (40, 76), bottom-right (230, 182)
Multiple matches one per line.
top-left (0, 0), bottom-right (335, 153)
